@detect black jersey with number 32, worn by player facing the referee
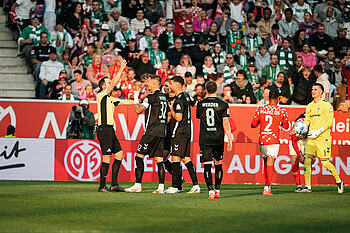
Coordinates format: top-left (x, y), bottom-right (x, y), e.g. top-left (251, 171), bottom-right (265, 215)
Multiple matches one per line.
top-left (142, 90), bottom-right (169, 137)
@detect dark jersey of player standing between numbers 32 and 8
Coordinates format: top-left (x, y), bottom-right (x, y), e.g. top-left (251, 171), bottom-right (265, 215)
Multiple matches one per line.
top-left (171, 92), bottom-right (191, 138)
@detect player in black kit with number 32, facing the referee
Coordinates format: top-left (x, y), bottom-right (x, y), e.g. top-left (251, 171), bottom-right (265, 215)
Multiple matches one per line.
top-left (125, 75), bottom-right (169, 193)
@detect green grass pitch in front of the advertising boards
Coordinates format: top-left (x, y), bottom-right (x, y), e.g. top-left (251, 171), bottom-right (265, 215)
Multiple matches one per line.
top-left (0, 181), bottom-right (350, 233)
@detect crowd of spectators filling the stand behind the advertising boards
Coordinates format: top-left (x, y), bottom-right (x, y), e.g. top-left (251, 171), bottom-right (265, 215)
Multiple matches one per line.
top-left (4, 0), bottom-right (350, 105)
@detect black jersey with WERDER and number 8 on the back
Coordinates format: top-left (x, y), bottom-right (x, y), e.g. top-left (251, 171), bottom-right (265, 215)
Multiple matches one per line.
top-left (196, 97), bottom-right (230, 145)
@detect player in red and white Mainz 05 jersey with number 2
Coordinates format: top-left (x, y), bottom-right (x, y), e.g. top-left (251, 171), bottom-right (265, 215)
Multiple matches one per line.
top-left (251, 91), bottom-right (289, 195)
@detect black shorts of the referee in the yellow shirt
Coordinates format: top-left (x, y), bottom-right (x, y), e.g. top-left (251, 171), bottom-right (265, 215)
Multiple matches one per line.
top-left (97, 125), bottom-right (122, 155)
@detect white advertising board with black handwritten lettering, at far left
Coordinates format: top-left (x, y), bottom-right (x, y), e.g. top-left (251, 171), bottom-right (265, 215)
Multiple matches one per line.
top-left (0, 138), bottom-right (55, 180)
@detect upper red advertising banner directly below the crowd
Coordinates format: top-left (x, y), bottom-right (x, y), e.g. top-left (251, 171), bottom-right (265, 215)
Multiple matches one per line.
top-left (0, 101), bottom-right (350, 145)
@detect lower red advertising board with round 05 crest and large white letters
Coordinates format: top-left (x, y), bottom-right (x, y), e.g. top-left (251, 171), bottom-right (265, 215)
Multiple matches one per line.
top-left (54, 140), bottom-right (350, 184)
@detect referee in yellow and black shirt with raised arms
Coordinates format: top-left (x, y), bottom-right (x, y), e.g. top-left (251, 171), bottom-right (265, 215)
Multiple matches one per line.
top-left (97, 57), bottom-right (126, 192)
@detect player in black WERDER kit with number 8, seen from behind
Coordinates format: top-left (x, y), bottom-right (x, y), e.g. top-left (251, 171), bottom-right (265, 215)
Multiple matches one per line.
top-left (196, 81), bottom-right (232, 199)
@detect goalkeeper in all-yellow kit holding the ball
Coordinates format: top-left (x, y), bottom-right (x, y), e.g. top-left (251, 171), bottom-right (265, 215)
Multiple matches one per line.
top-left (301, 83), bottom-right (344, 193)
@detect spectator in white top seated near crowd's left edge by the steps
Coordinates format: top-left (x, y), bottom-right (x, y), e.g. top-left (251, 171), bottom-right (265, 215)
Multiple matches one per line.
top-left (39, 49), bottom-right (64, 99)
